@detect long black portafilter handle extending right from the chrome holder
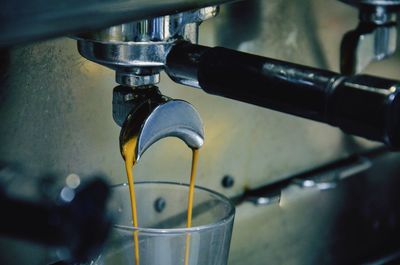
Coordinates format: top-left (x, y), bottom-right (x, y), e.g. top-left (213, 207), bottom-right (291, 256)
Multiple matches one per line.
top-left (166, 42), bottom-right (400, 149)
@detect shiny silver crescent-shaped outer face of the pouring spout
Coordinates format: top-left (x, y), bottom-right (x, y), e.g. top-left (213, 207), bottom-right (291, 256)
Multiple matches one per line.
top-left (136, 100), bottom-right (204, 160)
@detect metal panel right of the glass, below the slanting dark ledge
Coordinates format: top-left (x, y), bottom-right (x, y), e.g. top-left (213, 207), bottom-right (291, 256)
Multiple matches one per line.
top-left (229, 154), bottom-right (400, 265)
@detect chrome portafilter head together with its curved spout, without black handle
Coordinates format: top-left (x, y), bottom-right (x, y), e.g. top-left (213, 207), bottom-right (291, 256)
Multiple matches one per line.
top-left (75, 6), bottom-right (211, 160)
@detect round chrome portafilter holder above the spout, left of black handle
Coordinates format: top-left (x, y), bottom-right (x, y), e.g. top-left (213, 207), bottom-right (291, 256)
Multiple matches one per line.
top-left (75, 6), bottom-right (218, 86)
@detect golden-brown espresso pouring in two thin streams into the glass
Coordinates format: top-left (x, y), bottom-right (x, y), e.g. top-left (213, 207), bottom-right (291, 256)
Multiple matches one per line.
top-left (122, 136), bottom-right (199, 265)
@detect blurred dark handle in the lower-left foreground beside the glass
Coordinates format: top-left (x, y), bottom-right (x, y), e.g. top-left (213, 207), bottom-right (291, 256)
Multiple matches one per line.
top-left (0, 178), bottom-right (111, 263)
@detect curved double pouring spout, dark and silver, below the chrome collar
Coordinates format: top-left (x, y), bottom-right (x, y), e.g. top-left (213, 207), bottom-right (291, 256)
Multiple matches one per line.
top-left (114, 86), bottom-right (204, 161)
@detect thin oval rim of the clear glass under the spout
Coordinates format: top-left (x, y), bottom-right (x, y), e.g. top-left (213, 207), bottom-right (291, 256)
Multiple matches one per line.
top-left (111, 181), bottom-right (236, 234)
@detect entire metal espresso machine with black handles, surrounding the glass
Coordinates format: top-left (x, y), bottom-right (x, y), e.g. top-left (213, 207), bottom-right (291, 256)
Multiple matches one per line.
top-left (0, 0), bottom-right (400, 265)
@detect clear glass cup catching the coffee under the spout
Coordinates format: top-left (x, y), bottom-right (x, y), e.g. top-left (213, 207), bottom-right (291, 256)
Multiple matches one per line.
top-left (91, 182), bottom-right (235, 265)
